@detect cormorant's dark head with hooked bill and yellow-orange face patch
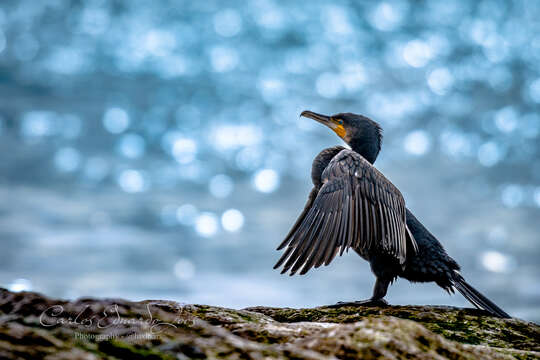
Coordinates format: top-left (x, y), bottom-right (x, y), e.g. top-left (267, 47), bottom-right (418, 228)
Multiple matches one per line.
top-left (300, 110), bottom-right (382, 163)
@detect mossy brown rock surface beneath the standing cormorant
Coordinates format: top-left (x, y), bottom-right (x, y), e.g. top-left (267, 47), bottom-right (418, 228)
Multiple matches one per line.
top-left (0, 289), bottom-right (540, 360)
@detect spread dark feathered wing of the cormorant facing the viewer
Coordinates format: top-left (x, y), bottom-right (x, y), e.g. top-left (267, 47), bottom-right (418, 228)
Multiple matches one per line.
top-left (274, 149), bottom-right (416, 275)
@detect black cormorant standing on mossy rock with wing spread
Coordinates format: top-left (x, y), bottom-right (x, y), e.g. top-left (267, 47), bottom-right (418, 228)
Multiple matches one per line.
top-left (274, 111), bottom-right (510, 318)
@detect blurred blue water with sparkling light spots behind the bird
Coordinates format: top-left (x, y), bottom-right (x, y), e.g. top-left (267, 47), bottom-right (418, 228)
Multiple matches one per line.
top-left (0, 0), bottom-right (540, 321)
